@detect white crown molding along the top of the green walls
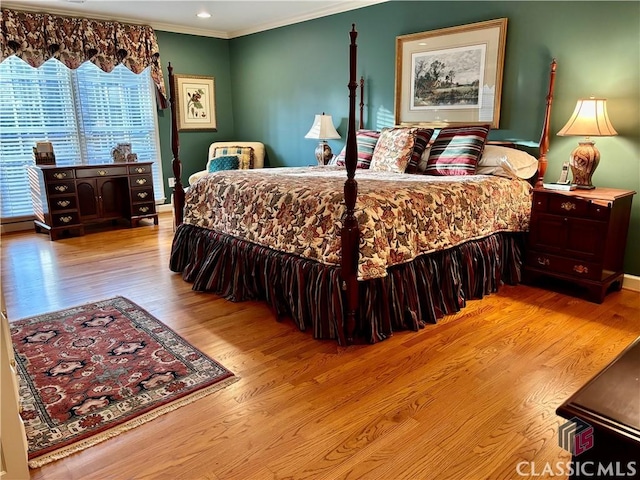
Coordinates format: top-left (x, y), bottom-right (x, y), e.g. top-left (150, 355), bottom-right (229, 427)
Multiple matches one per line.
top-left (2, 0), bottom-right (389, 40)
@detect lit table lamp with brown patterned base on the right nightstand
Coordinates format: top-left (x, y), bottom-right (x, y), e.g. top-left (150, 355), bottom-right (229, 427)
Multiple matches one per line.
top-left (558, 97), bottom-right (618, 189)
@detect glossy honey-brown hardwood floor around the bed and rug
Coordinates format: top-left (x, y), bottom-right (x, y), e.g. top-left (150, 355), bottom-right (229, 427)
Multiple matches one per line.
top-left (2, 215), bottom-right (640, 480)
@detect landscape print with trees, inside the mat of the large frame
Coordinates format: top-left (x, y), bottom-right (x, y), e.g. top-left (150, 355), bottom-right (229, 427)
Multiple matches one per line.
top-left (410, 44), bottom-right (486, 110)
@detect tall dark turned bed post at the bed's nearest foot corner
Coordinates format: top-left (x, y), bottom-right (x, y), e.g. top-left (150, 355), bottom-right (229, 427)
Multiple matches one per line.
top-left (339, 24), bottom-right (360, 344)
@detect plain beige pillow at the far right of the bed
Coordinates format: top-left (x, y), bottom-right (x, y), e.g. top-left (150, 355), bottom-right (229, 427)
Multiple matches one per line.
top-left (476, 145), bottom-right (538, 180)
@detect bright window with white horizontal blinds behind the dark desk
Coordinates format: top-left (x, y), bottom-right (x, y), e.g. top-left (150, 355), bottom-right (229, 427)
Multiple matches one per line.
top-left (0, 56), bottom-right (164, 220)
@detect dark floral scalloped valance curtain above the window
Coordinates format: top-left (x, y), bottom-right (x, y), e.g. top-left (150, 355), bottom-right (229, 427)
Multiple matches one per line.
top-left (0, 8), bottom-right (168, 108)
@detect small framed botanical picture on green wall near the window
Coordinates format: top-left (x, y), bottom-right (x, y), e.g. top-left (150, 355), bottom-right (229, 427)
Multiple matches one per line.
top-left (173, 75), bottom-right (217, 131)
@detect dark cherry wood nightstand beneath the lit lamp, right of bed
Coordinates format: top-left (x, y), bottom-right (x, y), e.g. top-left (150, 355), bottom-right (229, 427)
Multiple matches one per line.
top-left (524, 188), bottom-right (636, 303)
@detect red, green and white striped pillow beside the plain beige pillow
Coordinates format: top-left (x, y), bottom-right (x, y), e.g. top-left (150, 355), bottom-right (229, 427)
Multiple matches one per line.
top-left (424, 125), bottom-right (491, 175)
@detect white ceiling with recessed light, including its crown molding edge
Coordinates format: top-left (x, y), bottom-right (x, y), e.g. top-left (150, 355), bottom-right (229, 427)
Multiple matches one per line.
top-left (2, 0), bottom-right (387, 38)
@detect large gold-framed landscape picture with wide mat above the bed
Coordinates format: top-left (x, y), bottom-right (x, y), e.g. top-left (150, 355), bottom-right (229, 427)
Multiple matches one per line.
top-left (395, 18), bottom-right (507, 128)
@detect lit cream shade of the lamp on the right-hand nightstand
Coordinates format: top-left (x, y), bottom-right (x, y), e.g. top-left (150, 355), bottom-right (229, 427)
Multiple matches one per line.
top-left (558, 97), bottom-right (618, 137)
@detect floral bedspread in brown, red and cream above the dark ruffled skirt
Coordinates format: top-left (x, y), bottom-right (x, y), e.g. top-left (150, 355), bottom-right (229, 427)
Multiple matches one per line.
top-left (184, 167), bottom-right (531, 280)
